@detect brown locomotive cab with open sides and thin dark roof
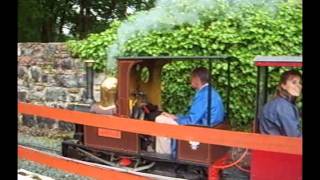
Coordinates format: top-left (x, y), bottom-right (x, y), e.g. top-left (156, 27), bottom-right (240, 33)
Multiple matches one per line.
top-left (84, 56), bottom-right (232, 166)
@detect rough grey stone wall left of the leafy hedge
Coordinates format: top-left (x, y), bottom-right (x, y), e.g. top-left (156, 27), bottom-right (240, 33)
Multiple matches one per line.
top-left (18, 43), bottom-right (105, 128)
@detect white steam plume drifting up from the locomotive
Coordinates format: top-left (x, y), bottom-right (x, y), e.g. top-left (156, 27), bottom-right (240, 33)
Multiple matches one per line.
top-left (107, 0), bottom-right (280, 69)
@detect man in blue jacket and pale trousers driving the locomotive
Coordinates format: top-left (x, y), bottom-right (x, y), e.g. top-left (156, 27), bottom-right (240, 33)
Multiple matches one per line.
top-left (155, 67), bottom-right (224, 154)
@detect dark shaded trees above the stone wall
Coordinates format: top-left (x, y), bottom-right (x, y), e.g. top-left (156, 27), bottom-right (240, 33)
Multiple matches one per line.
top-left (17, 0), bottom-right (155, 42)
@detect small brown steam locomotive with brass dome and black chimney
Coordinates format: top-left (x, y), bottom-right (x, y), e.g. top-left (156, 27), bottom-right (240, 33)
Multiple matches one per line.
top-left (62, 56), bottom-right (232, 179)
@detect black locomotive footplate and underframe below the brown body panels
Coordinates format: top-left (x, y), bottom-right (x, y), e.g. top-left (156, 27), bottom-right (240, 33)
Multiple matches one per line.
top-left (62, 140), bottom-right (208, 179)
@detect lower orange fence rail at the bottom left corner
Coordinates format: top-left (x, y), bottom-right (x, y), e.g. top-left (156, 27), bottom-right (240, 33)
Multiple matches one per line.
top-left (18, 145), bottom-right (148, 180)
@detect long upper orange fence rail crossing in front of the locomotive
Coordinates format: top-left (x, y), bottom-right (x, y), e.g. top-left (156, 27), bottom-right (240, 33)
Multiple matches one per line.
top-left (18, 102), bottom-right (302, 155)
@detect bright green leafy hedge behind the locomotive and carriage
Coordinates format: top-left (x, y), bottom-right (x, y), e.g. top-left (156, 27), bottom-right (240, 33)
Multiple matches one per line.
top-left (69, 3), bottom-right (302, 129)
